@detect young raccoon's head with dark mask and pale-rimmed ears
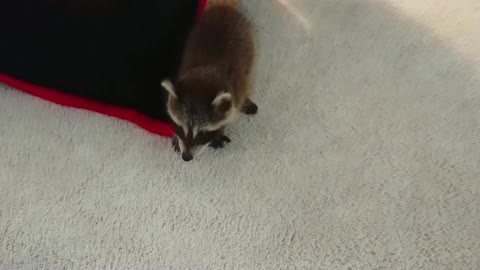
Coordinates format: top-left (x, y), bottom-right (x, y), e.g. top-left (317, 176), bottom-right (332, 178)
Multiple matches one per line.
top-left (162, 73), bottom-right (236, 161)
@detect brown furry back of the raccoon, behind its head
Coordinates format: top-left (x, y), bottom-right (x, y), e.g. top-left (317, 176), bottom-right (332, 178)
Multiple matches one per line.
top-left (180, 5), bottom-right (255, 103)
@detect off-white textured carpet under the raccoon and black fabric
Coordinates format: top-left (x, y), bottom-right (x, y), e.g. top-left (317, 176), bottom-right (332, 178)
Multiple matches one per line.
top-left (0, 0), bottom-right (480, 270)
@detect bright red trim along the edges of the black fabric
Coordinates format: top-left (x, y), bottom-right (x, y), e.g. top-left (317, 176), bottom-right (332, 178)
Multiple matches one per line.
top-left (0, 0), bottom-right (208, 137)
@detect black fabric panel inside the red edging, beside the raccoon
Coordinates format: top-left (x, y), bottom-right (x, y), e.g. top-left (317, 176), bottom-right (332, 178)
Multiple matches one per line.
top-left (0, 0), bottom-right (197, 121)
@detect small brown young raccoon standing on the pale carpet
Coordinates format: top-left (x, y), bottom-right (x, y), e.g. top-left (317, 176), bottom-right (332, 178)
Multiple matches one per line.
top-left (162, 0), bottom-right (258, 161)
